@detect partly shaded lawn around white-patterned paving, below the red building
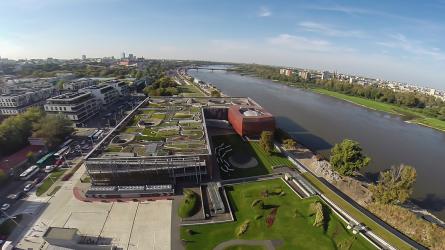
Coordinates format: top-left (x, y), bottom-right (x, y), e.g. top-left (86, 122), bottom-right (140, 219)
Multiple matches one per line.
top-left (212, 134), bottom-right (293, 179)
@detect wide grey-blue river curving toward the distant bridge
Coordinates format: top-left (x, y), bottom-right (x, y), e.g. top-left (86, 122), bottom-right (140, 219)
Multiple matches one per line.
top-left (188, 69), bottom-right (445, 220)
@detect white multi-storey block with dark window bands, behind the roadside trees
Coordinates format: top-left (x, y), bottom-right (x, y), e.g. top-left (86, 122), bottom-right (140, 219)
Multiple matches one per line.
top-left (44, 92), bottom-right (99, 125)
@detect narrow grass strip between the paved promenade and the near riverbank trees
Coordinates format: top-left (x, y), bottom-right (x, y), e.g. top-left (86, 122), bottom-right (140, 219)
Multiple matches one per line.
top-left (302, 172), bottom-right (410, 249)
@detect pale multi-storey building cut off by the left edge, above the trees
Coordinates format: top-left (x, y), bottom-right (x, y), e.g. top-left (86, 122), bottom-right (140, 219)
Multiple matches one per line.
top-left (0, 87), bottom-right (56, 116)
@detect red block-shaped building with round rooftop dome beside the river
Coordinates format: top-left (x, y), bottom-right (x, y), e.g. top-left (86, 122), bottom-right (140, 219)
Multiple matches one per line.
top-left (228, 106), bottom-right (275, 136)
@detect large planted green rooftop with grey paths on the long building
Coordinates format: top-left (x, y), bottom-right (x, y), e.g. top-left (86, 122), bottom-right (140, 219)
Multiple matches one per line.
top-left (87, 97), bottom-right (255, 159)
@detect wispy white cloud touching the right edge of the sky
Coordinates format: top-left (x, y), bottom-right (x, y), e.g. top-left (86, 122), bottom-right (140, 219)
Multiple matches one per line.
top-left (377, 33), bottom-right (445, 60)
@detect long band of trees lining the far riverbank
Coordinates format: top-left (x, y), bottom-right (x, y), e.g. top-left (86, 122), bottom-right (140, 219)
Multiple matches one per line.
top-left (234, 64), bottom-right (445, 120)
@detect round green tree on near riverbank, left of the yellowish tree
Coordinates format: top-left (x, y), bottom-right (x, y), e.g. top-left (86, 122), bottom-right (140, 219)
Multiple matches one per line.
top-left (330, 139), bottom-right (371, 176)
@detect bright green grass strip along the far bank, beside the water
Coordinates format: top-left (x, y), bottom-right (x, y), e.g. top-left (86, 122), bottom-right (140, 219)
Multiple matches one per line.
top-left (312, 88), bottom-right (445, 131)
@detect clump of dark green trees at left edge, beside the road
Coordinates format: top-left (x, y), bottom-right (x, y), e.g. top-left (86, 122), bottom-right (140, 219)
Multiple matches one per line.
top-left (0, 108), bottom-right (74, 156)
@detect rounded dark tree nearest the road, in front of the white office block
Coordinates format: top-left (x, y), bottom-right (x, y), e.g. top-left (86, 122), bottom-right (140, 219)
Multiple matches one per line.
top-left (33, 115), bottom-right (74, 148)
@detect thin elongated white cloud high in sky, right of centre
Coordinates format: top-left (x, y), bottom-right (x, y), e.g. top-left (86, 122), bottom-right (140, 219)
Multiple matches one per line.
top-left (298, 21), bottom-right (365, 38)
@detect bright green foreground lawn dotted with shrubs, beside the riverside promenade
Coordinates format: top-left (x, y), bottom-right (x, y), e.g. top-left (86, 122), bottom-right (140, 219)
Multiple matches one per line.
top-left (181, 179), bottom-right (373, 250)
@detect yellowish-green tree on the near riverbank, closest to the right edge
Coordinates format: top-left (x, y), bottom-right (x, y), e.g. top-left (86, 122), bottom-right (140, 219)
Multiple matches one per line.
top-left (370, 164), bottom-right (417, 204)
